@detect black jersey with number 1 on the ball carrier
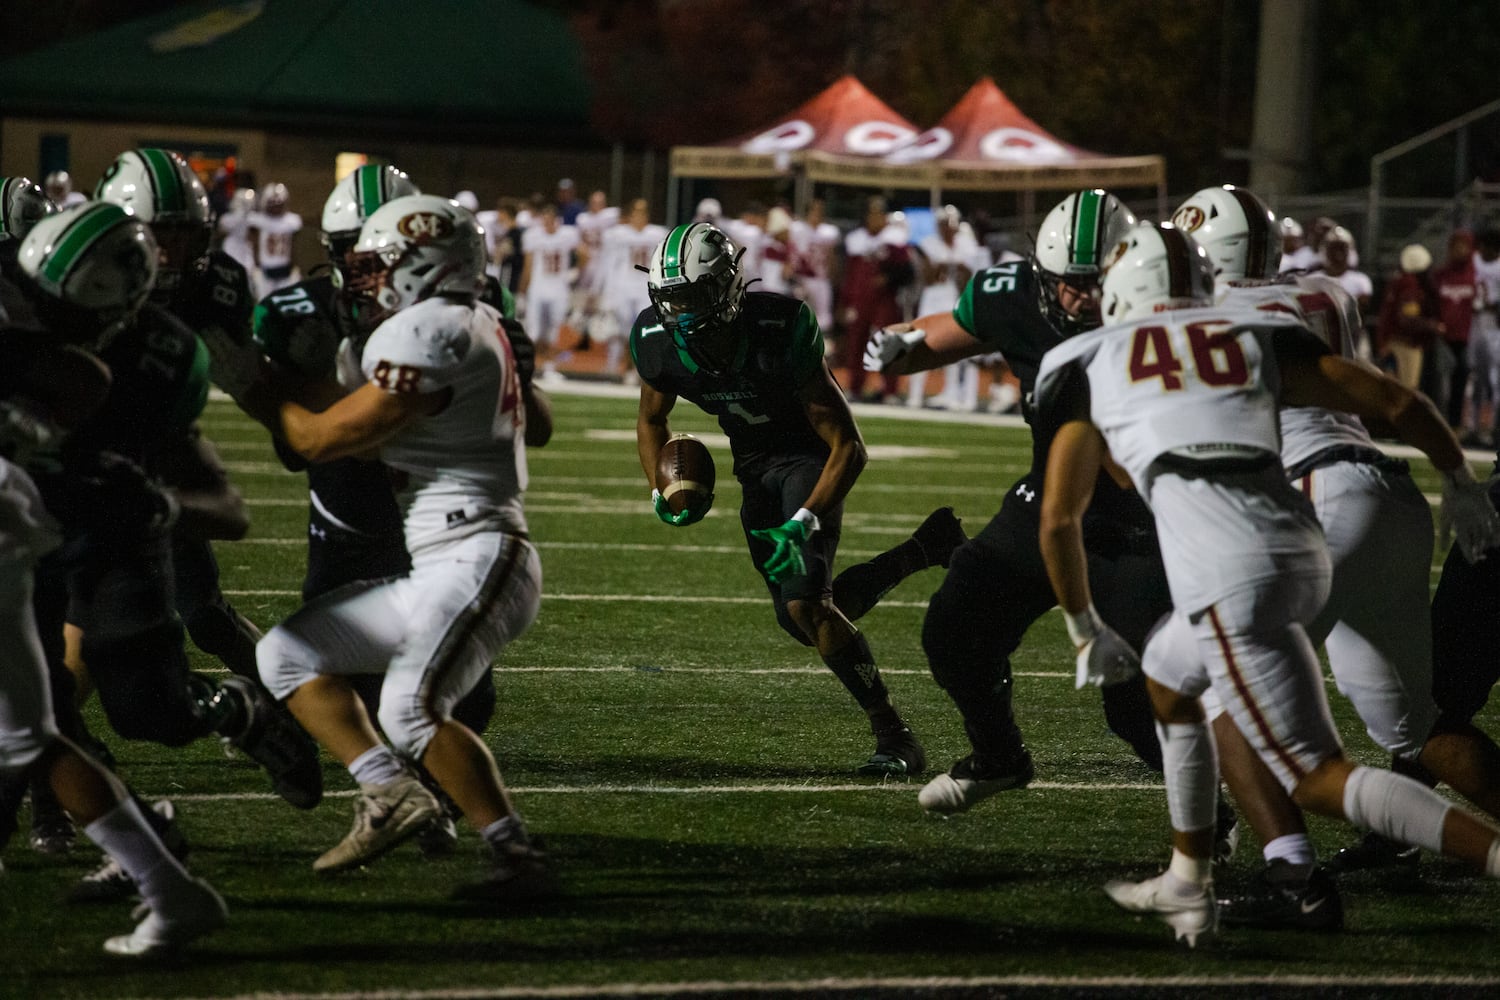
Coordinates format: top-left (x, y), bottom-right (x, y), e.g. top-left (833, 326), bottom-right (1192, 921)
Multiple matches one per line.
top-left (630, 292), bottom-right (828, 477)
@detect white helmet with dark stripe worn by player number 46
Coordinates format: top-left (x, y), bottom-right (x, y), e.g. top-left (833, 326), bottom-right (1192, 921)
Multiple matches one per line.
top-left (1101, 222), bottom-right (1214, 324)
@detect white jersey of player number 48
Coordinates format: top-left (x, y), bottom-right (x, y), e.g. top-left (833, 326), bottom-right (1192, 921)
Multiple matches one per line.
top-left (360, 298), bottom-right (527, 555)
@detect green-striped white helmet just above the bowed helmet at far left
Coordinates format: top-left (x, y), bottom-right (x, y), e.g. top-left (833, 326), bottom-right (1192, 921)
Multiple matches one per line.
top-left (95, 148), bottom-right (213, 295)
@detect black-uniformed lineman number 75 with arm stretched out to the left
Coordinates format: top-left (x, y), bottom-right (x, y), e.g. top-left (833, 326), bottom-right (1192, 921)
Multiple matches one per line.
top-left (864, 189), bottom-right (1170, 815)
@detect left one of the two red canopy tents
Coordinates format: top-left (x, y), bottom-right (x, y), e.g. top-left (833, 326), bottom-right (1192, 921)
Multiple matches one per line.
top-left (668, 76), bottom-right (926, 219)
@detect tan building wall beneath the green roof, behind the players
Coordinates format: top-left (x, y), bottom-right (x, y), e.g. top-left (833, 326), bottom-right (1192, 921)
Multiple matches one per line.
top-left (0, 118), bottom-right (666, 270)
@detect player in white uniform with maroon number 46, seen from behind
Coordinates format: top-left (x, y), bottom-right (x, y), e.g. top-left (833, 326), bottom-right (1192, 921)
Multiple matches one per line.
top-left (1037, 223), bottom-right (1500, 946)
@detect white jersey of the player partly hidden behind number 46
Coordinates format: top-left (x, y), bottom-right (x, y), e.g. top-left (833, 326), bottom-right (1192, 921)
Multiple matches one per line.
top-left (1218, 274), bottom-right (1374, 469)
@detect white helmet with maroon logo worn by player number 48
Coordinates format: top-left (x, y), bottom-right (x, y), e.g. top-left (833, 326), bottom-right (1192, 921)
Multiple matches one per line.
top-left (345, 195), bottom-right (485, 330)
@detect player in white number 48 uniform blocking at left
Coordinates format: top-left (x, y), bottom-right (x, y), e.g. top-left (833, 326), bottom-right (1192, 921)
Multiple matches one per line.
top-left (215, 195), bottom-right (551, 903)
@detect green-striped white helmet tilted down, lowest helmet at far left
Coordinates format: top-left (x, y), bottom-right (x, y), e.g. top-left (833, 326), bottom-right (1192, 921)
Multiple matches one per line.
top-left (20, 201), bottom-right (158, 343)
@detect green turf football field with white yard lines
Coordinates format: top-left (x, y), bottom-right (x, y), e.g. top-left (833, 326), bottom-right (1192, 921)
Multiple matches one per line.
top-left (0, 394), bottom-right (1500, 997)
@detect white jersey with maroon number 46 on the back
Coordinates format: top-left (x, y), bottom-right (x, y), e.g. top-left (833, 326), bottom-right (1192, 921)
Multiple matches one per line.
top-left (1037, 307), bottom-right (1328, 499)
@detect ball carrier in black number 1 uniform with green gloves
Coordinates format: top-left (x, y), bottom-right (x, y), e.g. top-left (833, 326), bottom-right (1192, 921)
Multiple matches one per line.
top-left (630, 222), bottom-right (965, 777)
